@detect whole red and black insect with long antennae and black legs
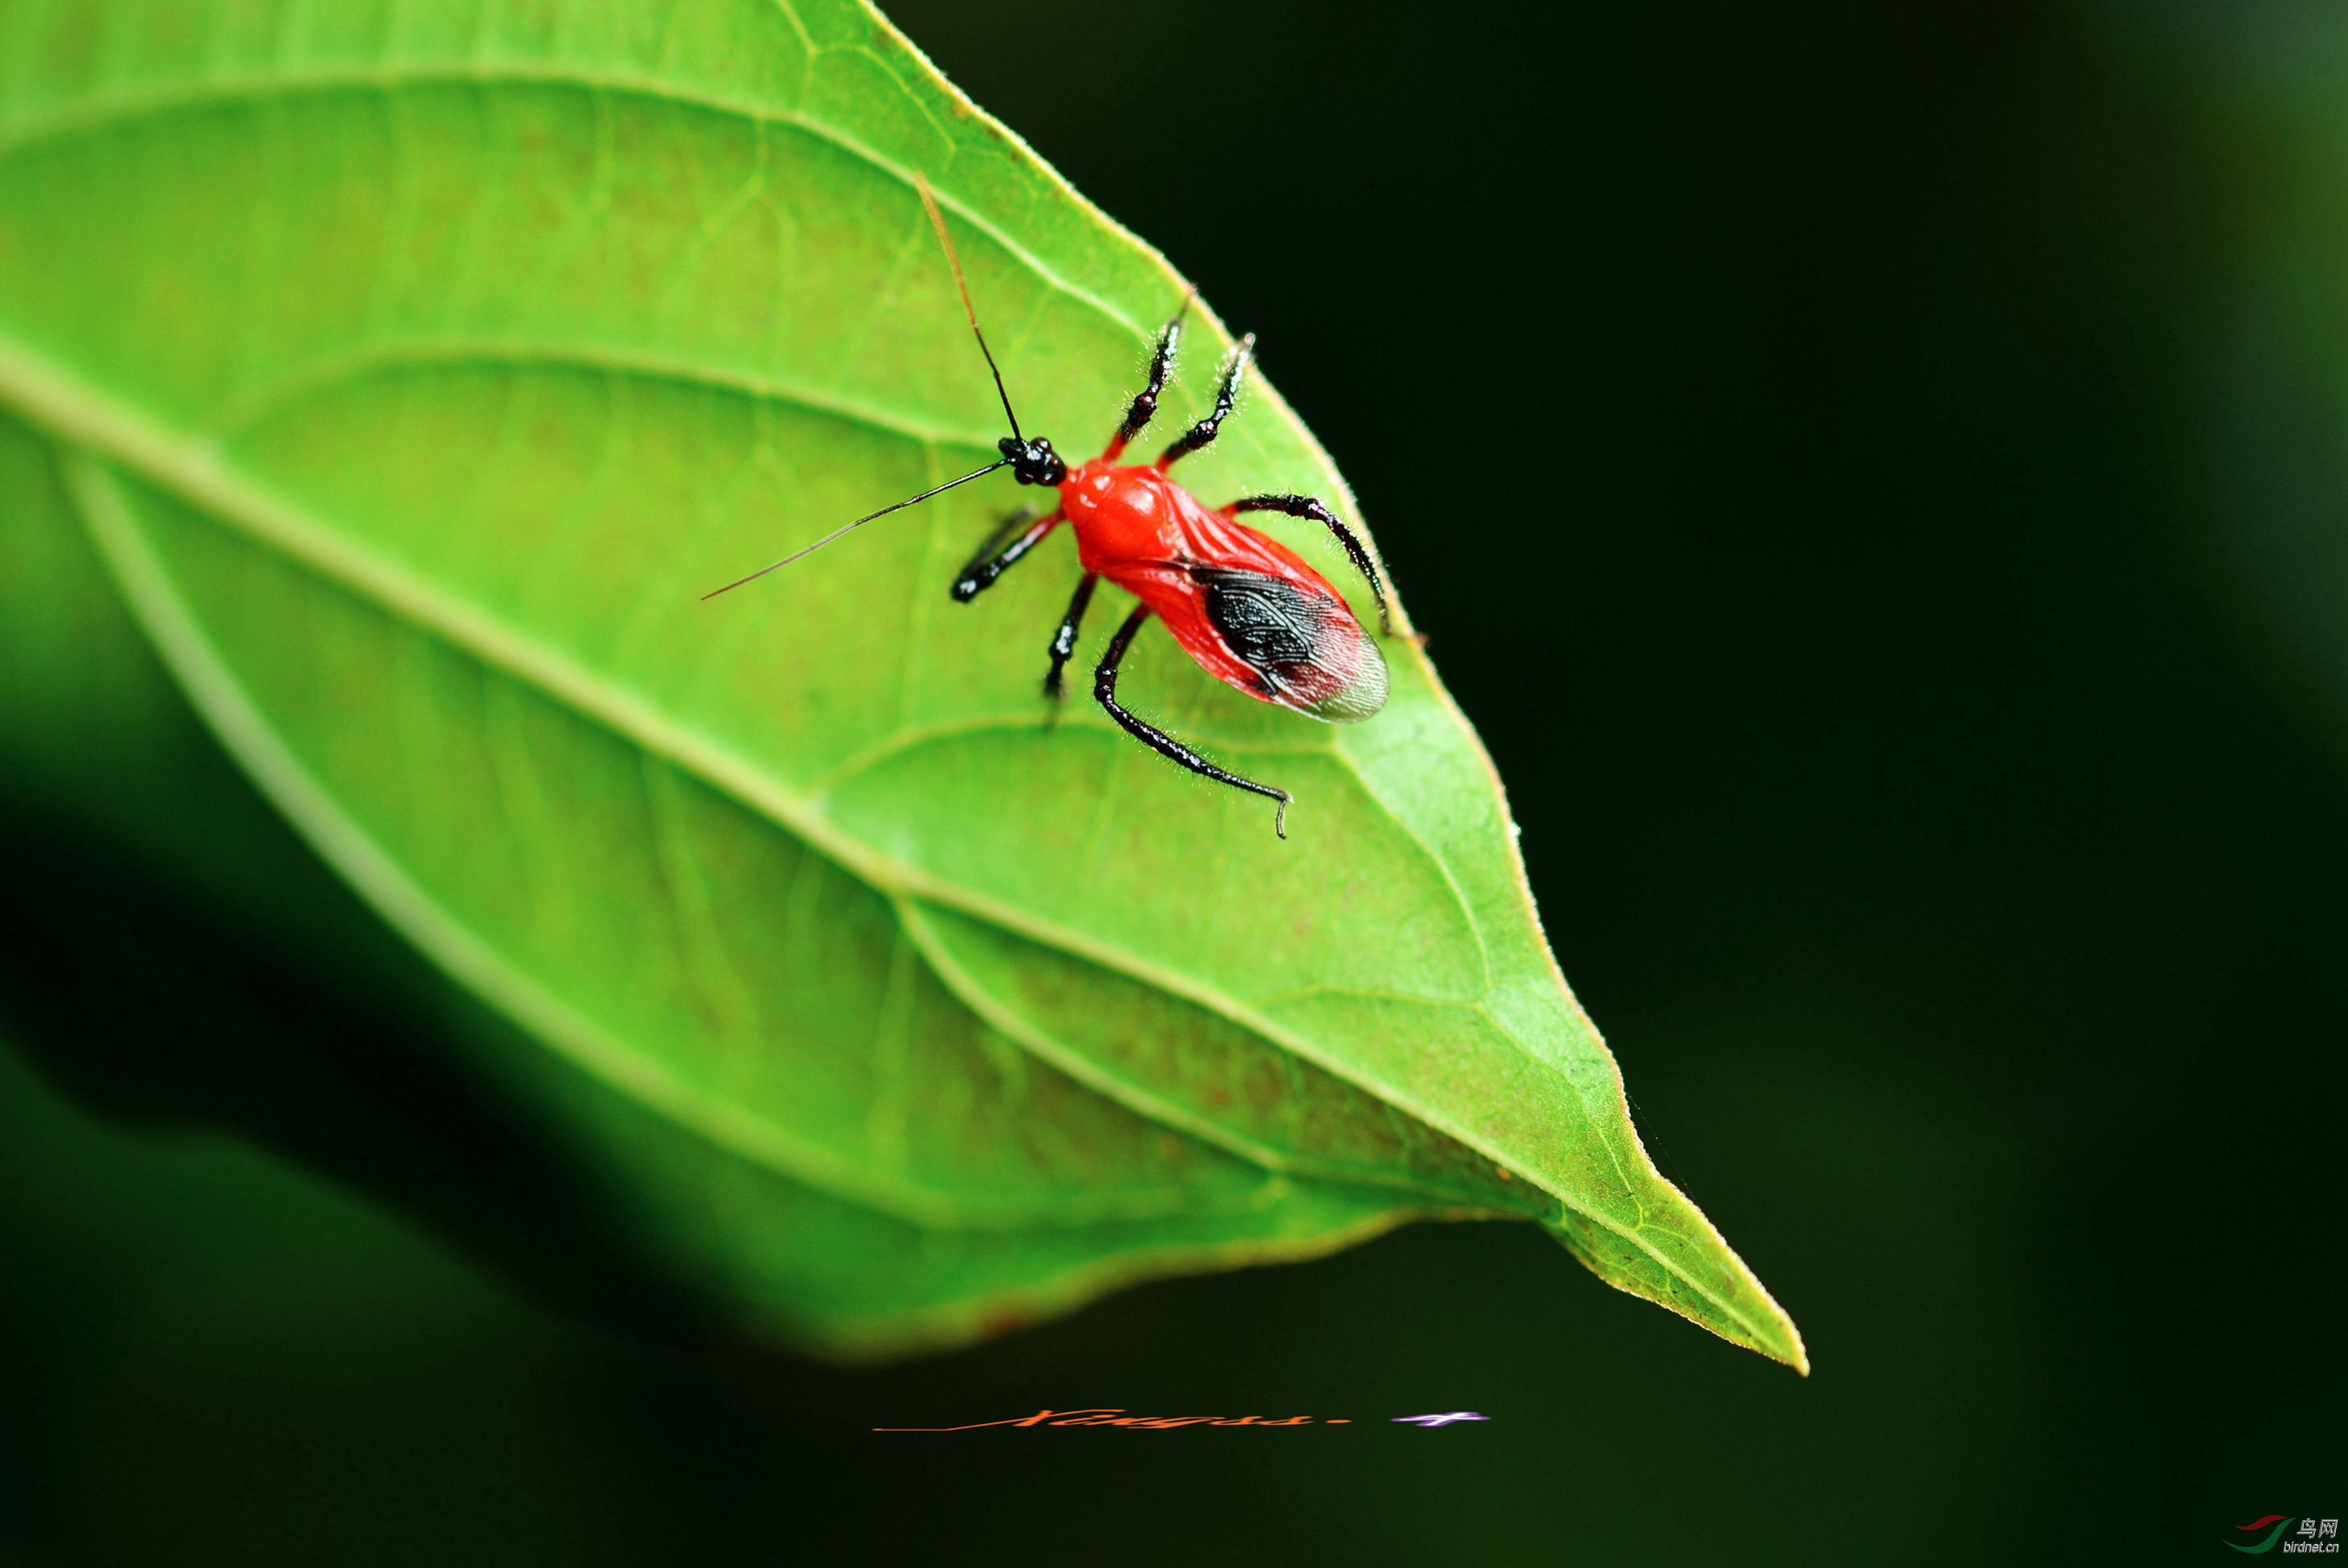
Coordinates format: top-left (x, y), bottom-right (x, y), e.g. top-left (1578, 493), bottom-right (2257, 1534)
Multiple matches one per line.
top-left (702, 176), bottom-right (1392, 838)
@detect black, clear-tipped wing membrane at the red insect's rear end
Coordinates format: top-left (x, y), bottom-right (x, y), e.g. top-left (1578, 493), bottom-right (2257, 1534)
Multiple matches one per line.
top-left (1190, 566), bottom-right (1385, 723)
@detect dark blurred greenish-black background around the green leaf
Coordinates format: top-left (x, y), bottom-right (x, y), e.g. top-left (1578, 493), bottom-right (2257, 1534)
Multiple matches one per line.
top-left (0, 0), bottom-right (2348, 1566)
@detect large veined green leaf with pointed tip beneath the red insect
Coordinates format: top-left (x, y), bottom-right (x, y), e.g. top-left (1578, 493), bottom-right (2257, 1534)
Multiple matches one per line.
top-left (0, 0), bottom-right (1805, 1366)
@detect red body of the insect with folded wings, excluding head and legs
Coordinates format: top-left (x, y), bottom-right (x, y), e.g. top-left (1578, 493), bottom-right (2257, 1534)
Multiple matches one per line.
top-left (1059, 458), bottom-right (1387, 723)
